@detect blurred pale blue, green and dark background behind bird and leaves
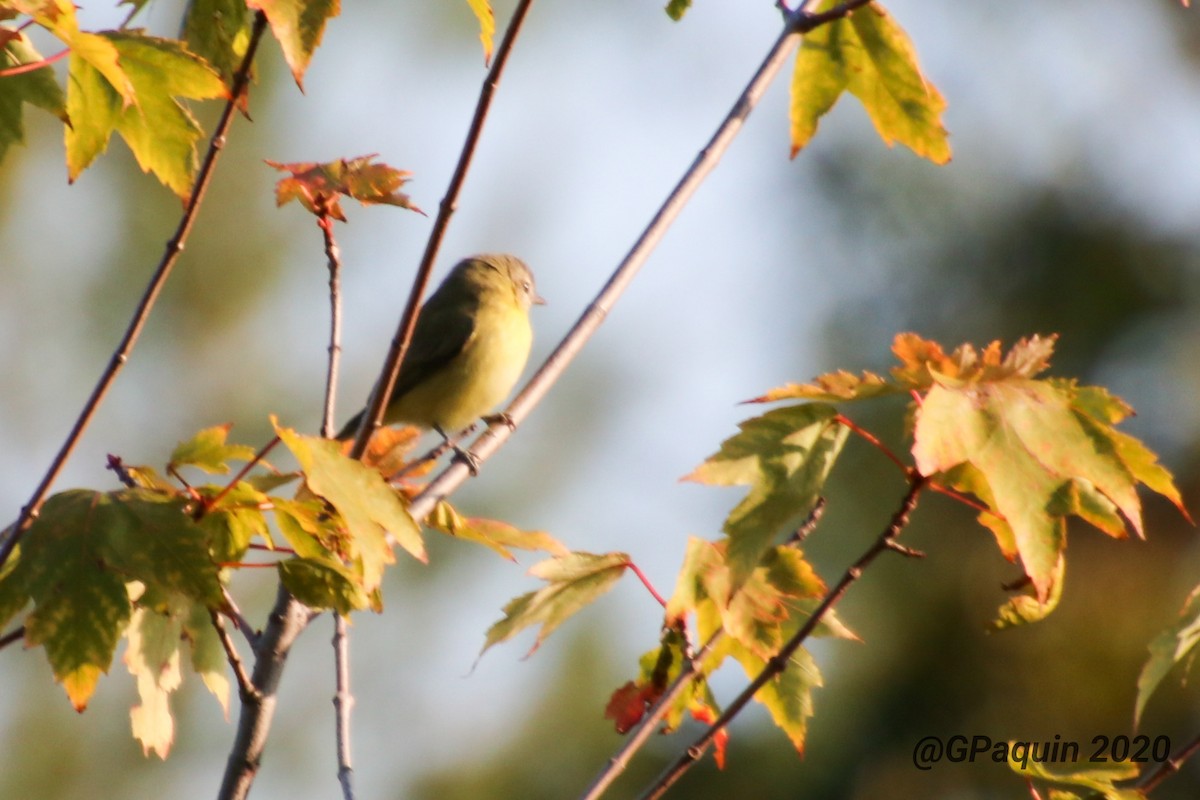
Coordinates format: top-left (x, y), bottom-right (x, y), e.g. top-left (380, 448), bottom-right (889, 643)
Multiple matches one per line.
top-left (0, 0), bottom-right (1200, 800)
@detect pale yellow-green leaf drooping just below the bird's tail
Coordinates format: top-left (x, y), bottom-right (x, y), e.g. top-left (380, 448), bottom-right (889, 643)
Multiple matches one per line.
top-left (272, 420), bottom-right (428, 582)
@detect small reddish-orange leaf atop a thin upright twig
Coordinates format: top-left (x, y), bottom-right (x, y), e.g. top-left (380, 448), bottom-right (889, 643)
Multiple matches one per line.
top-left (266, 155), bottom-right (425, 222)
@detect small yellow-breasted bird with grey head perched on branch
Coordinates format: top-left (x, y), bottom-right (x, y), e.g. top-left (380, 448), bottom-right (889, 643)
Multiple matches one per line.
top-left (337, 253), bottom-right (546, 448)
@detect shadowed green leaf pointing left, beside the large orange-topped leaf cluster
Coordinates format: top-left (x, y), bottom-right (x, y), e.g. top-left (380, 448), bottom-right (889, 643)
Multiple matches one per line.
top-left (684, 403), bottom-right (848, 593)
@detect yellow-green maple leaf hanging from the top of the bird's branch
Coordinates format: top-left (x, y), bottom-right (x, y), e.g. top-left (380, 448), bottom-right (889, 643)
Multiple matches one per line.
top-left (791, 0), bottom-right (950, 164)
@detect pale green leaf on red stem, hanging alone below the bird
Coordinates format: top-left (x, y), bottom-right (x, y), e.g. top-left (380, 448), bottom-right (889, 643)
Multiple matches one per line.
top-left (479, 553), bottom-right (629, 656)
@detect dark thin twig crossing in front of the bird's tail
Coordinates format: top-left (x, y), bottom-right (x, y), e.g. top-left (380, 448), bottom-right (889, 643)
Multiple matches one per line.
top-left (350, 0), bottom-right (533, 458)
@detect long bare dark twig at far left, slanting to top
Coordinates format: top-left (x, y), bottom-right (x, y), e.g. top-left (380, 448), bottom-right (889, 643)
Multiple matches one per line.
top-left (0, 11), bottom-right (266, 575)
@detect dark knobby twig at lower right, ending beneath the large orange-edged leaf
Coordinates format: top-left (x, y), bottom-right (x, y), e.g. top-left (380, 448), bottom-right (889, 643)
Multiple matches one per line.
top-left (642, 471), bottom-right (928, 800)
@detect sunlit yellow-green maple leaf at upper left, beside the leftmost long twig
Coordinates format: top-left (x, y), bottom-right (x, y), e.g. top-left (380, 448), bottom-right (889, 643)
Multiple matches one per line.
top-left (66, 31), bottom-right (226, 197)
